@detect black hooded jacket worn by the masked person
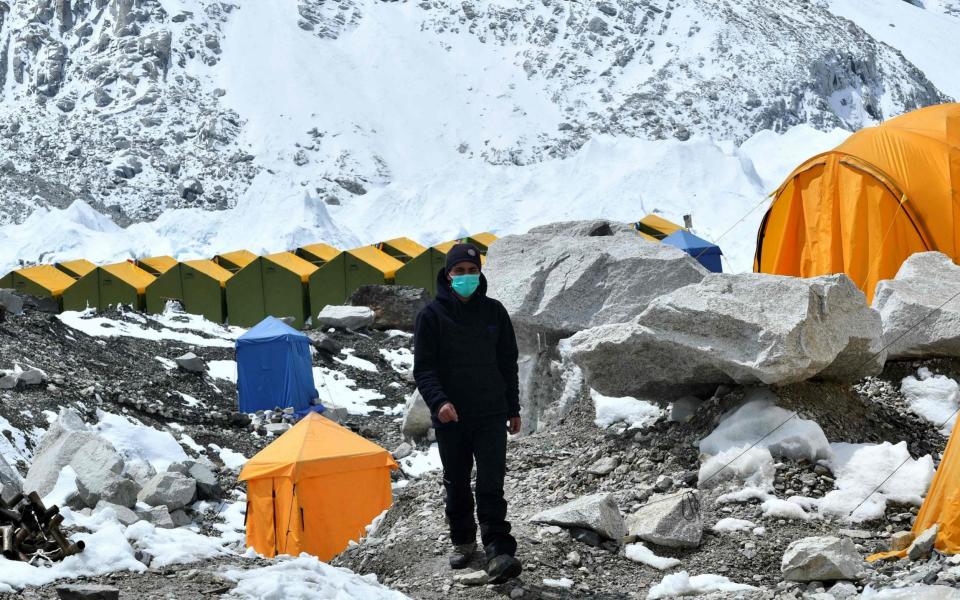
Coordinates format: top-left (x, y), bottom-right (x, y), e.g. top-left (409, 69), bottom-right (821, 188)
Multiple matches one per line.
top-left (413, 269), bottom-right (520, 427)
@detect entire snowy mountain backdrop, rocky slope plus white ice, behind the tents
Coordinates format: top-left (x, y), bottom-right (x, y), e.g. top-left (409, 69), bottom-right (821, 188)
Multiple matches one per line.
top-left (0, 0), bottom-right (960, 269)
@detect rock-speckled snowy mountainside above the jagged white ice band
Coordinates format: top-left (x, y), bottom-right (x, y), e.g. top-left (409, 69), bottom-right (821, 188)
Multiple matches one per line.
top-left (0, 0), bottom-right (949, 230)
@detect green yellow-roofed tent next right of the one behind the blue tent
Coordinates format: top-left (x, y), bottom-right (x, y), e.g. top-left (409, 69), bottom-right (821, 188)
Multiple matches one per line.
top-left (310, 246), bottom-right (403, 315)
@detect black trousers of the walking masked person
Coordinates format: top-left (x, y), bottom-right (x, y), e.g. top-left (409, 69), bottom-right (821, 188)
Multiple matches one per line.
top-left (436, 417), bottom-right (517, 560)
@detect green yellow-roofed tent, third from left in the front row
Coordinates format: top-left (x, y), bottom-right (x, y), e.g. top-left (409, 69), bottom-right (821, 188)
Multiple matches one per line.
top-left (146, 260), bottom-right (233, 323)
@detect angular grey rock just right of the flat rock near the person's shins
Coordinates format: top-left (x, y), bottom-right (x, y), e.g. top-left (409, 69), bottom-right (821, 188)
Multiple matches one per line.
top-left (626, 490), bottom-right (703, 548)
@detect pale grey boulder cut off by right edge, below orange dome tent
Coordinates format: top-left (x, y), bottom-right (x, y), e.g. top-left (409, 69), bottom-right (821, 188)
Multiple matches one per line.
top-left (873, 252), bottom-right (960, 359)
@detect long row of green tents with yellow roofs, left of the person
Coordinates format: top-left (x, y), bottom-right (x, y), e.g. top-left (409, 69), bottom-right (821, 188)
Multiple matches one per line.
top-left (0, 232), bottom-right (497, 328)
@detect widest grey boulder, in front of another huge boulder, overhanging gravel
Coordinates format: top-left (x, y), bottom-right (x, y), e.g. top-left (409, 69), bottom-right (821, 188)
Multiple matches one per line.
top-left (570, 273), bottom-right (885, 400)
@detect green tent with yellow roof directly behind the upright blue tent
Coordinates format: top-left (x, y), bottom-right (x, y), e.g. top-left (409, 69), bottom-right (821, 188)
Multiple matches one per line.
top-left (227, 252), bottom-right (317, 329)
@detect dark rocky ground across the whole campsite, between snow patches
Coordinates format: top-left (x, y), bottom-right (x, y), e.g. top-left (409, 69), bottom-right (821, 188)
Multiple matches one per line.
top-left (0, 278), bottom-right (960, 600)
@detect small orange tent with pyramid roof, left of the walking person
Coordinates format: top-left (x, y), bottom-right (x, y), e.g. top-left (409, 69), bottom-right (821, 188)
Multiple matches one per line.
top-left (240, 413), bottom-right (397, 561)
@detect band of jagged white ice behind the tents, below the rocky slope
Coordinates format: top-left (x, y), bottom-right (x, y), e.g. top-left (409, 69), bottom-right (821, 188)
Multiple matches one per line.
top-left (0, 123), bottom-right (848, 276)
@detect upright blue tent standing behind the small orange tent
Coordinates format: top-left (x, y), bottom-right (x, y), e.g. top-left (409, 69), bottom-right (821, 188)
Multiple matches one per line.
top-left (237, 317), bottom-right (323, 414)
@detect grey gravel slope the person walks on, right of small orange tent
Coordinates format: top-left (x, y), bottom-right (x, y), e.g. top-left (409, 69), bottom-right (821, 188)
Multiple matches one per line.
top-left (335, 370), bottom-right (960, 598)
